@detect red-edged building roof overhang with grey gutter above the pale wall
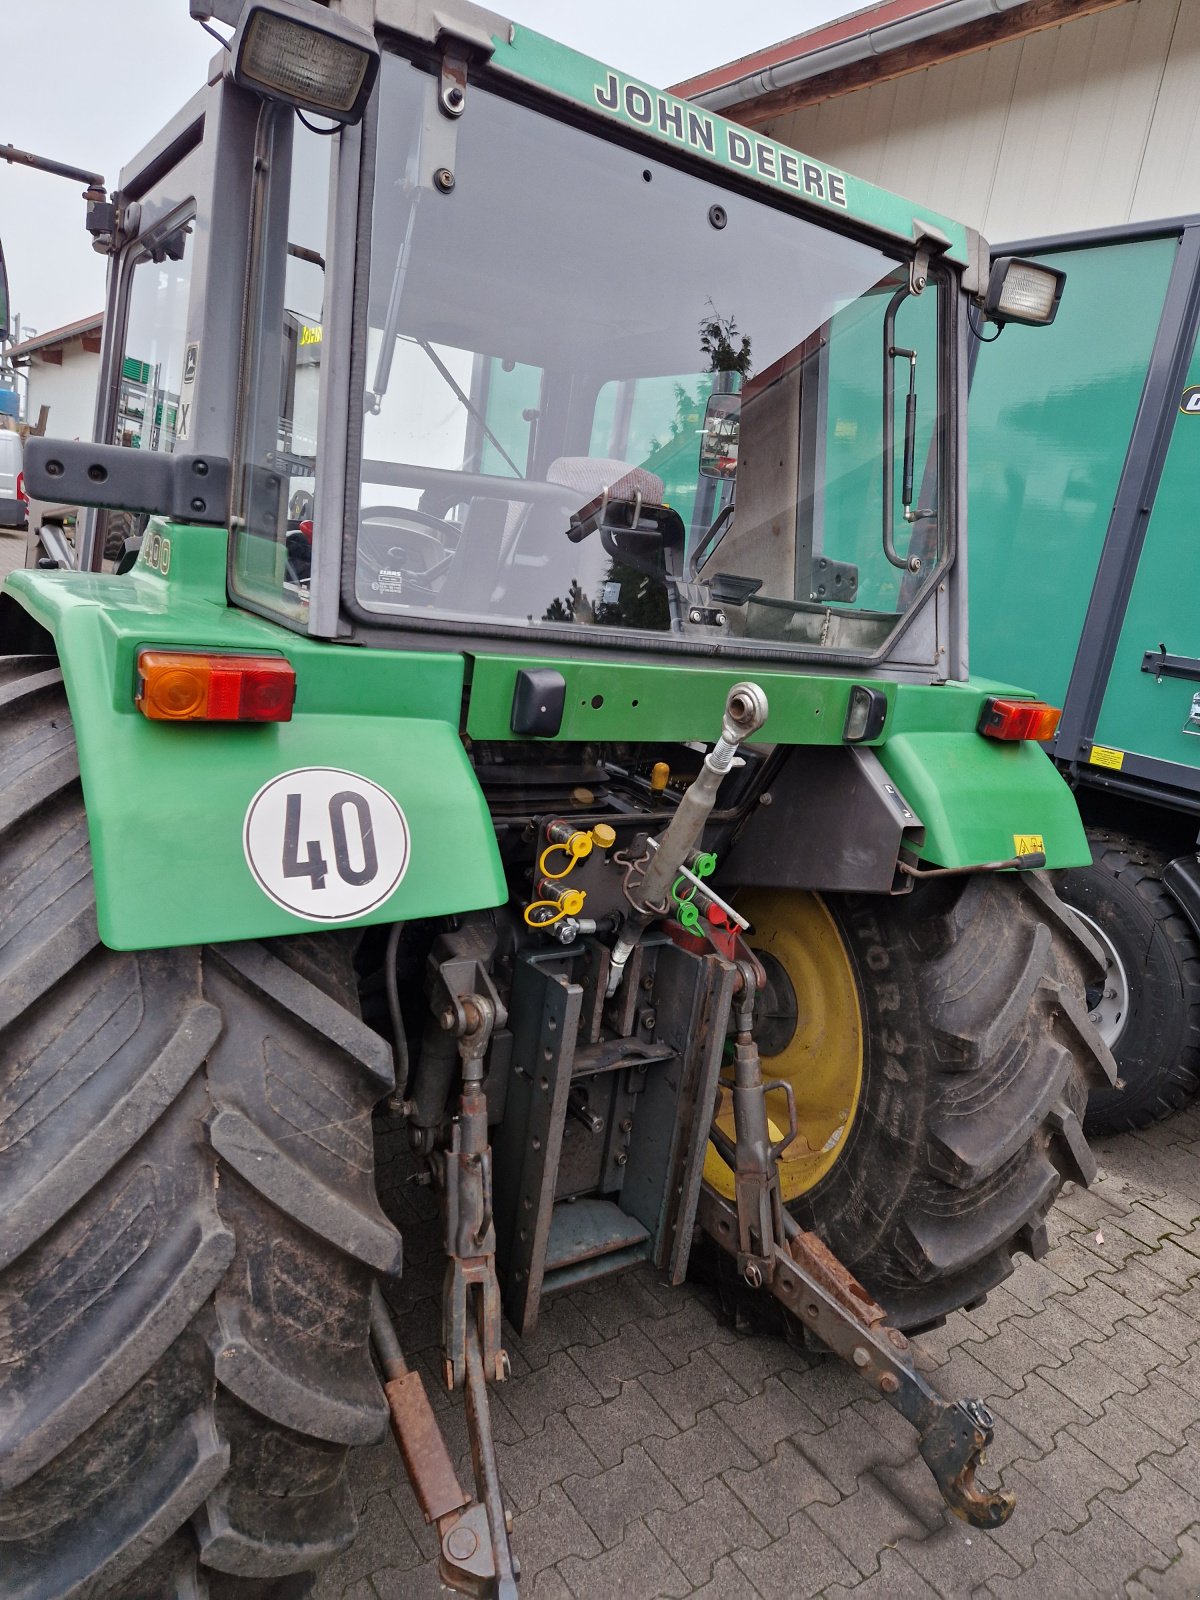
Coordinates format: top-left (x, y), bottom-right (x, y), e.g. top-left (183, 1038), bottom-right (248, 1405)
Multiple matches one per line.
top-left (675, 0), bottom-right (1128, 123)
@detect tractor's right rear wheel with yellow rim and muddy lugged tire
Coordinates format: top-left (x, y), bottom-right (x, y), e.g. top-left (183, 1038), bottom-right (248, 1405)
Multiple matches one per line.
top-left (706, 874), bottom-right (1112, 1330)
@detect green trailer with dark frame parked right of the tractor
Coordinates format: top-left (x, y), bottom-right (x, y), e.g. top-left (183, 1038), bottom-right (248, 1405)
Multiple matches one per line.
top-left (970, 218), bottom-right (1200, 1131)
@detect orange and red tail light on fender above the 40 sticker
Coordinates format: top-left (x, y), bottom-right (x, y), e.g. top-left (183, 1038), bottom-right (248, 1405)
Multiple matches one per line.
top-left (134, 650), bottom-right (296, 722)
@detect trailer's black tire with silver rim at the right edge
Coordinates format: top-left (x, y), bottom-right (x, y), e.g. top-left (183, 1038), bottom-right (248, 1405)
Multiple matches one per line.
top-left (1058, 830), bottom-right (1200, 1134)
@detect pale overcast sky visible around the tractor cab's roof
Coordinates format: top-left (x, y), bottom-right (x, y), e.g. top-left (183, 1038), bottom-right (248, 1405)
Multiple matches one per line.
top-left (0, 0), bottom-right (844, 333)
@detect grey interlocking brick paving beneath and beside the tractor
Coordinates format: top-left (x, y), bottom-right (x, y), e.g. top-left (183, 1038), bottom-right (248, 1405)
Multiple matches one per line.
top-left (317, 1110), bottom-right (1200, 1600)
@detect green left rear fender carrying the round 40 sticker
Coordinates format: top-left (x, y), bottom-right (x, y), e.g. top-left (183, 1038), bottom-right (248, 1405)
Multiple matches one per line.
top-left (5, 523), bottom-right (509, 950)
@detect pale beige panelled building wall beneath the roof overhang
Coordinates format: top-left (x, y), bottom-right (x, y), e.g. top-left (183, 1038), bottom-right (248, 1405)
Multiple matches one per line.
top-left (763, 0), bottom-right (1200, 240)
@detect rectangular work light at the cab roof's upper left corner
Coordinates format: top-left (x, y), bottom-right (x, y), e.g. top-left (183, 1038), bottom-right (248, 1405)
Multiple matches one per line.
top-left (232, 0), bottom-right (379, 123)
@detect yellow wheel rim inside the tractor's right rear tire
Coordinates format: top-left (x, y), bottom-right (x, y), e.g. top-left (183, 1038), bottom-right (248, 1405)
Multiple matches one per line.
top-left (704, 890), bottom-right (862, 1203)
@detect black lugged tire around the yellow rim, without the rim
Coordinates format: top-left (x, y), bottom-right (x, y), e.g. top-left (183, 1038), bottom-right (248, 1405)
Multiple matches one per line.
top-left (792, 874), bottom-right (1114, 1330)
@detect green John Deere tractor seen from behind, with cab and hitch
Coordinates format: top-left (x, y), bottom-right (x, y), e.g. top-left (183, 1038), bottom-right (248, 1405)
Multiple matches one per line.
top-left (0, 0), bottom-right (1112, 1600)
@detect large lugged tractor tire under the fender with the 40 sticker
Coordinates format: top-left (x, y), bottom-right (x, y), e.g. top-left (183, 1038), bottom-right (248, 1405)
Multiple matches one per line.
top-left (0, 656), bottom-right (400, 1600)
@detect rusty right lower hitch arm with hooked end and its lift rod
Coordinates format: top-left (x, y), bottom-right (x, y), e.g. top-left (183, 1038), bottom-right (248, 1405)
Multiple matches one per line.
top-left (698, 963), bottom-right (1014, 1528)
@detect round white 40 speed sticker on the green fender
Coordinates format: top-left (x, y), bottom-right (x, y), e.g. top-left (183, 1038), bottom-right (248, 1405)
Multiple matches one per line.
top-left (242, 766), bottom-right (410, 922)
